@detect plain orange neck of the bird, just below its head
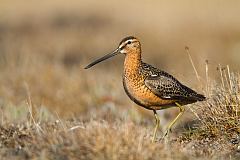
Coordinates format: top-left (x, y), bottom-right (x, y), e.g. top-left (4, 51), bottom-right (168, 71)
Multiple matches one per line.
top-left (124, 51), bottom-right (142, 77)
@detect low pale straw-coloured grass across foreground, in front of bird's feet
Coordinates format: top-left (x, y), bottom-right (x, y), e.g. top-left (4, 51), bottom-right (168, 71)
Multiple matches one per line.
top-left (1, 120), bottom-right (187, 159)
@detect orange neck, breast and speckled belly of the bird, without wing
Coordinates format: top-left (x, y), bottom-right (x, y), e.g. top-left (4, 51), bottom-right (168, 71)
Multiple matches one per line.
top-left (123, 47), bottom-right (175, 110)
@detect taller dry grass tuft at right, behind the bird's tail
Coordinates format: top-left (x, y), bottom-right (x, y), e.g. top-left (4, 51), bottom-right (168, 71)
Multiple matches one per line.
top-left (182, 65), bottom-right (240, 156)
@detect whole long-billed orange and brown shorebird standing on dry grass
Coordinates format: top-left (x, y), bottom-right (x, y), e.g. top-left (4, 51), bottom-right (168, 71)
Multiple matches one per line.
top-left (85, 36), bottom-right (205, 142)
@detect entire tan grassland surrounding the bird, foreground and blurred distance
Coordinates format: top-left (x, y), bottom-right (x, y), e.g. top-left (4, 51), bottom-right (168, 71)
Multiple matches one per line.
top-left (0, 0), bottom-right (240, 160)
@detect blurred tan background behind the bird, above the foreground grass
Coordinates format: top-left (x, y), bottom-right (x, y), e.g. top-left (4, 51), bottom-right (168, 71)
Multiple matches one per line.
top-left (0, 0), bottom-right (240, 121)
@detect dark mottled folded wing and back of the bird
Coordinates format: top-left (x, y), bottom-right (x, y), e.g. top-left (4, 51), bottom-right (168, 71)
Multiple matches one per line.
top-left (141, 62), bottom-right (205, 103)
